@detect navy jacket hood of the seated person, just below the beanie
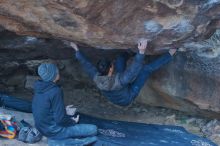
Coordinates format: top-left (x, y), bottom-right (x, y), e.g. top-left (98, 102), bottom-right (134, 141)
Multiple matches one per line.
top-left (34, 80), bottom-right (57, 93)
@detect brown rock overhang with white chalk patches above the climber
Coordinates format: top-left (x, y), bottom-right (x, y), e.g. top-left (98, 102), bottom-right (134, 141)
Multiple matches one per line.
top-left (0, 0), bottom-right (220, 52)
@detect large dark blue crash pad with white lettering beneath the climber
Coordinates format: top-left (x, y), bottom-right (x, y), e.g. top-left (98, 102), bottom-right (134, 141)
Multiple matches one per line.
top-left (50, 114), bottom-right (217, 146)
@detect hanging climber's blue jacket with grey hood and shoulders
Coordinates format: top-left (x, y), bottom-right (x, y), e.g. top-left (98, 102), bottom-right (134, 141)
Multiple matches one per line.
top-left (76, 51), bottom-right (144, 106)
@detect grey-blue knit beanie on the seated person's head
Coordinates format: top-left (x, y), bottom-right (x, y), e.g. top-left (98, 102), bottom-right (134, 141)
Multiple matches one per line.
top-left (38, 63), bottom-right (59, 82)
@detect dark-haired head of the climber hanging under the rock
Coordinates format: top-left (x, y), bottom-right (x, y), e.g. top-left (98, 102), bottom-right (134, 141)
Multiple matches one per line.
top-left (97, 58), bottom-right (114, 76)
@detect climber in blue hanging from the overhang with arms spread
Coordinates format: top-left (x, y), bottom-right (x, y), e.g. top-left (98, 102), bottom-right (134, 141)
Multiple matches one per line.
top-left (70, 39), bottom-right (176, 106)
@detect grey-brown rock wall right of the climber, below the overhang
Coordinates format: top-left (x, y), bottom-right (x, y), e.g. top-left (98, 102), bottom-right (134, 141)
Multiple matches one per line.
top-left (139, 50), bottom-right (220, 118)
